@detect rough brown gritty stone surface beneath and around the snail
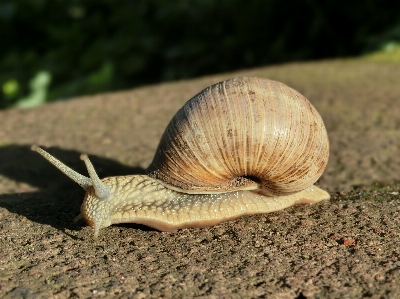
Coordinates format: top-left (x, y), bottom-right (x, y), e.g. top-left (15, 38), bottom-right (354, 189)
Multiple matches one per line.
top-left (0, 60), bottom-right (400, 298)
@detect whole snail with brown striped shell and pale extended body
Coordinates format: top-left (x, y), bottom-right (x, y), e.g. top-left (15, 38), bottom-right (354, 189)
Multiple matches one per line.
top-left (32, 77), bottom-right (329, 239)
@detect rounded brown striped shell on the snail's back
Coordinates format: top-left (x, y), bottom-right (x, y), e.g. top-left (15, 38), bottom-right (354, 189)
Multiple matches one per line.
top-left (146, 77), bottom-right (329, 195)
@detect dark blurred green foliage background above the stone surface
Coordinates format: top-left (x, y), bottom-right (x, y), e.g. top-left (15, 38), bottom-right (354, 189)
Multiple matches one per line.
top-left (0, 0), bottom-right (400, 109)
